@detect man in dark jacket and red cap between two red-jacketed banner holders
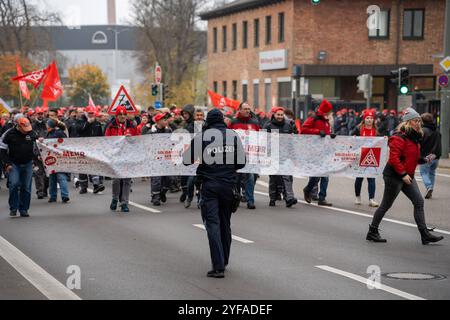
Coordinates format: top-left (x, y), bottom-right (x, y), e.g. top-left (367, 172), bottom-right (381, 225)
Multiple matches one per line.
top-left (264, 107), bottom-right (298, 208)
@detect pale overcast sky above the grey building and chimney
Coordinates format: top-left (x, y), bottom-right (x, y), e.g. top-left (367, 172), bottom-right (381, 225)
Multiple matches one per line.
top-left (35, 0), bottom-right (227, 25)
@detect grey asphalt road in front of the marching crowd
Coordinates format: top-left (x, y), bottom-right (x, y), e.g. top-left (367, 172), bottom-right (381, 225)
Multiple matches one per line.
top-left (0, 170), bottom-right (450, 300)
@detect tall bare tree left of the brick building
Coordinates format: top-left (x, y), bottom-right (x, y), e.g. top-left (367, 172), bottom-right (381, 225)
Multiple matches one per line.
top-left (133, 0), bottom-right (207, 86)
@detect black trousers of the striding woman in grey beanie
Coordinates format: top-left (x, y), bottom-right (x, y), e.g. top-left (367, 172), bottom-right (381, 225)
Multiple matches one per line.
top-left (372, 176), bottom-right (427, 229)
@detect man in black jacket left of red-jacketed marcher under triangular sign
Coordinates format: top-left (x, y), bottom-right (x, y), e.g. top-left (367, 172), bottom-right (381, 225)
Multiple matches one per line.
top-left (76, 107), bottom-right (105, 194)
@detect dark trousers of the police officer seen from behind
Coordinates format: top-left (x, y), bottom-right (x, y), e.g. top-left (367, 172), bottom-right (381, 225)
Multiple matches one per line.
top-left (201, 180), bottom-right (233, 270)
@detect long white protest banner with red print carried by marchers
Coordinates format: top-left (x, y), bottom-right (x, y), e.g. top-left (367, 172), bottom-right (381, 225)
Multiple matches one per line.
top-left (39, 131), bottom-right (388, 178)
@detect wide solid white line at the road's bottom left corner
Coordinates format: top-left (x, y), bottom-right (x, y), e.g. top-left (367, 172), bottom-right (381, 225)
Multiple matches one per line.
top-left (0, 236), bottom-right (81, 300)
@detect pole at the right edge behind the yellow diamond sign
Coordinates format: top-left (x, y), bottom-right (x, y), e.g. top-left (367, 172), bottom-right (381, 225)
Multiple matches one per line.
top-left (440, 0), bottom-right (450, 159)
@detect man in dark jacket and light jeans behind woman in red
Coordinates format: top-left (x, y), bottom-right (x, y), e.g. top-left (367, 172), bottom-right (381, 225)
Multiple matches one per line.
top-left (420, 113), bottom-right (442, 199)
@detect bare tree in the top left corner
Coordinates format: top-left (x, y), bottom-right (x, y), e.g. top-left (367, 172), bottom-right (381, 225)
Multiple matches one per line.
top-left (0, 0), bottom-right (61, 56)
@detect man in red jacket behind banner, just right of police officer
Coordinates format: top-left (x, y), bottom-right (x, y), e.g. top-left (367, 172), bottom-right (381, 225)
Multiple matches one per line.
top-left (229, 102), bottom-right (261, 210)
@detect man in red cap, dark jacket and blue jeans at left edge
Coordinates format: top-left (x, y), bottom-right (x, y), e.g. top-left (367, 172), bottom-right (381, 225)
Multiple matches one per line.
top-left (0, 116), bottom-right (38, 217)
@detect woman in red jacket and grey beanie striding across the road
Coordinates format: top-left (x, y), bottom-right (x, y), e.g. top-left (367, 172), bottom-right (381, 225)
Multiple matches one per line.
top-left (367, 108), bottom-right (444, 245)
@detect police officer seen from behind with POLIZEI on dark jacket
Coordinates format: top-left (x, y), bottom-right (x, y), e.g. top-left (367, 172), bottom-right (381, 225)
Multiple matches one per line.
top-left (184, 109), bottom-right (246, 278)
